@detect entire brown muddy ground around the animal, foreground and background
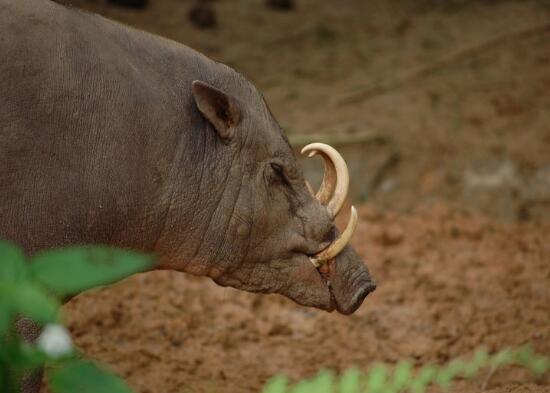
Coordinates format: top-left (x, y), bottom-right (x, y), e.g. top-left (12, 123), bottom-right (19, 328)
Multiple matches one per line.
top-left (54, 0), bottom-right (550, 393)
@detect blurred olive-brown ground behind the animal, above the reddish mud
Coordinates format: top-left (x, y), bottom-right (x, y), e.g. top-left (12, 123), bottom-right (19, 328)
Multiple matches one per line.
top-left (55, 0), bottom-right (550, 220)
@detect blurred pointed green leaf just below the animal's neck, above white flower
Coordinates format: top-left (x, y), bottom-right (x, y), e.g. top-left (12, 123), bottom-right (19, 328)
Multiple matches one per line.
top-left (30, 246), bottom-right (152, 296)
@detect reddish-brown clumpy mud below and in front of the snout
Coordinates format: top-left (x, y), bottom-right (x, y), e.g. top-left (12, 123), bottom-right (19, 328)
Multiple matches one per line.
top-left (66, 205), bottom-right (550, 393)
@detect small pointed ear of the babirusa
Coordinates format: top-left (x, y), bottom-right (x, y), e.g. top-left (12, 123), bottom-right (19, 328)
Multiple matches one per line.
top-left (192, 80), bottom-right (241, 140)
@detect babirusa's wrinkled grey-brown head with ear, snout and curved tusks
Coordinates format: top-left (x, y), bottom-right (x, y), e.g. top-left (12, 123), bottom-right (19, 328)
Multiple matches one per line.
top-left (157, 81), bottom-right (375, 314)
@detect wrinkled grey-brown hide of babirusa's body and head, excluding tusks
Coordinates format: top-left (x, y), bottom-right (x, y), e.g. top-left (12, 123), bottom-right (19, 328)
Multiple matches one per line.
top-left (0, 0), bottom-right (374, 388)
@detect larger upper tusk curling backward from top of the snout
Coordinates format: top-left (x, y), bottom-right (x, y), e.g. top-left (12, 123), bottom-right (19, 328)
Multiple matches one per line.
top-left (302, 143), bottom-right (349, 218)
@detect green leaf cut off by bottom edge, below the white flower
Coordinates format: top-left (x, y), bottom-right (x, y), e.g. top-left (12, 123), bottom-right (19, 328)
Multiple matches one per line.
top-left (48, 360), bottom-right (132, 393)
